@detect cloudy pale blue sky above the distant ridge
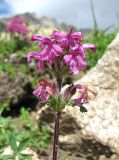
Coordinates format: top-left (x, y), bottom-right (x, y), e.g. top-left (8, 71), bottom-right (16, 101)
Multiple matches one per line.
top-left (0, 0), bottom-right (119, 29)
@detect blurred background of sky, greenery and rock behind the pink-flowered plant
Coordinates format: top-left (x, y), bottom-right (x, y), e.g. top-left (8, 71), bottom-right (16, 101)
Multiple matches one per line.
top-left (0, 0), bottom-right (119, 160)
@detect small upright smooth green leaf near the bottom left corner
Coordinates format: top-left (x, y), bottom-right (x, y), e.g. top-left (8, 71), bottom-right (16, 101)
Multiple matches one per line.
top-left (9, 135), bottom-right (18, 153)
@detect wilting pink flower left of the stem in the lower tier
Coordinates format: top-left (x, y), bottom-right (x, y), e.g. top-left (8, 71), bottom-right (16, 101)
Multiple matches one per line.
top-left (33, 79), bottom-right (53, 103)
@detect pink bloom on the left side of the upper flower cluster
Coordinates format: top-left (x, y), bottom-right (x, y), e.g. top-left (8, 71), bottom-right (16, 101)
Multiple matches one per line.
top-left (28, 35), bottom-right (63, 64)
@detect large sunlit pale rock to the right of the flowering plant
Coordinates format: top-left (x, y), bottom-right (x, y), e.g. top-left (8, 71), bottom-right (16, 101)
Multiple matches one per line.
top-left (65, 34), bottom-right (119, 154)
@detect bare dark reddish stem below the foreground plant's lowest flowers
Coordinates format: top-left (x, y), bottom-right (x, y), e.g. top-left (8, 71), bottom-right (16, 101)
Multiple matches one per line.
top-left (52, 112), bottom-right (61, 160)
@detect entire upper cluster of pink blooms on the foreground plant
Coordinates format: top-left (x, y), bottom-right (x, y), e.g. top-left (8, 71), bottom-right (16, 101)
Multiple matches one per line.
top-left (27, 28), bottom-right (96, 75)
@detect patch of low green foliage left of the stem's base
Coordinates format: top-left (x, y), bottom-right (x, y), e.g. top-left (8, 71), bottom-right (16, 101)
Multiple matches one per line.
top-left (0, 107), bottom-right (49, 160)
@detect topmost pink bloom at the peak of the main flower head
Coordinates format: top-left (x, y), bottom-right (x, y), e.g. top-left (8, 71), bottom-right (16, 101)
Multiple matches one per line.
top-left (51, 28), bottom-right (83, 49)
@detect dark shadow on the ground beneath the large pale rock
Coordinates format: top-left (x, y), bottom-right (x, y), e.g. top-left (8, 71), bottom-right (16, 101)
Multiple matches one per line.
top-left (60, 138), bottom-right (114, 160)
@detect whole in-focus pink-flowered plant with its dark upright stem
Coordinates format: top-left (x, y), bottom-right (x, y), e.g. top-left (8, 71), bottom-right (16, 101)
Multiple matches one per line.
top-left (27, 27), bottom-right (97, 160)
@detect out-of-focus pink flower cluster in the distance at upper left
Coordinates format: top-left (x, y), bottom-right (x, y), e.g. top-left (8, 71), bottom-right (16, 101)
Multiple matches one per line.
top-left (6, 17), bottom-right (28, 36)
